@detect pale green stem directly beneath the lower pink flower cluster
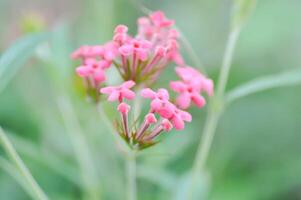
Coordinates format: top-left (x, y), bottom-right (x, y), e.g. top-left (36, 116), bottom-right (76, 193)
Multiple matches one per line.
top-left (126, 150), bottom-right (137, 200)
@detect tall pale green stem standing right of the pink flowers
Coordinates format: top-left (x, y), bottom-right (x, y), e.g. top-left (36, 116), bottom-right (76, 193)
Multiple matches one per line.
top-left (188, 28), bottom-right (240, 199)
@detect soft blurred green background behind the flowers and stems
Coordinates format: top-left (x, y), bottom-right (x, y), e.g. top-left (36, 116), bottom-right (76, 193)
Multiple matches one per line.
top-left (0, 0), bottom-right (301, 200)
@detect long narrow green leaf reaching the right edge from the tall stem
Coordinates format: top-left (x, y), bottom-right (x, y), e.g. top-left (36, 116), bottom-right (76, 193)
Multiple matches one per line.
top-left (226, 69), bottom-right (301, 104)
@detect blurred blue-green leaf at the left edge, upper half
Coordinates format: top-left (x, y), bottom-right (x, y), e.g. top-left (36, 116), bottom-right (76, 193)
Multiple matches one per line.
top-left (0, 33), bottom-right (48, 92)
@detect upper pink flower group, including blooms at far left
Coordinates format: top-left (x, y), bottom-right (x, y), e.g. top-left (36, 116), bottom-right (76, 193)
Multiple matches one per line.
top-left (71, 11), bottom-right (184, 96)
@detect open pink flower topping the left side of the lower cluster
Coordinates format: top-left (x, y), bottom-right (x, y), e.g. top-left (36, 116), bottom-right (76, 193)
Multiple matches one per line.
top-left (100, 81), bottom-right (135, 102)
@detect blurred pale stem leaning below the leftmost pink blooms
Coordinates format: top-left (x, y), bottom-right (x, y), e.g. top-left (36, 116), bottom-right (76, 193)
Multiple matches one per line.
top-left (58, 97), bottom-right (100, 200)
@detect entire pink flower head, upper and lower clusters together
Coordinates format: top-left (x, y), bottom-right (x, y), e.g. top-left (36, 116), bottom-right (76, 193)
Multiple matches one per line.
top-left (72, 11), bottom-right (213, 149)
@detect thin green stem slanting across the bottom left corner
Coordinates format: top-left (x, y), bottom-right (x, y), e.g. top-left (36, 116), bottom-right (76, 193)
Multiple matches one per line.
top-left (0, 127), bottom-right (48, 200)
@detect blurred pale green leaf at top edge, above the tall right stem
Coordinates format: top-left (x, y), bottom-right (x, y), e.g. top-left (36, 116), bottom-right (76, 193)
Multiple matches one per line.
top-left (232, 0), bottom-right (256, 29)
